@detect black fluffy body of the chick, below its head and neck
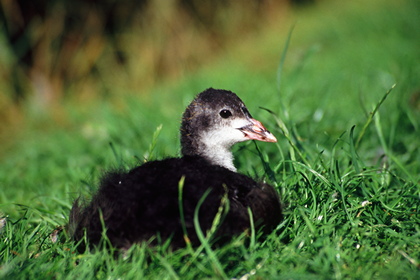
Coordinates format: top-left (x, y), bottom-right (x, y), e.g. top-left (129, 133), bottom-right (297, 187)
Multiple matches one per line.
top-left (70, 156), bottom-right (282, 248)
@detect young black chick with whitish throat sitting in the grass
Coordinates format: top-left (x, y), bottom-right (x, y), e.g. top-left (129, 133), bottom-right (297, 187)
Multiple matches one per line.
top-left (69, 89), bottom-right (282, 249)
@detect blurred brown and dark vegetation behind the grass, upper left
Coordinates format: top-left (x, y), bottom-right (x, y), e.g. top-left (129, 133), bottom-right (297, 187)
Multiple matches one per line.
top-left (0, 0), bottom-right (315, 140)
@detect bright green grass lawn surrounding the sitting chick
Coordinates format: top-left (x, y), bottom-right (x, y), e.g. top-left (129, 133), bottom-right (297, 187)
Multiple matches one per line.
top-left (0, 0), bottom-right (420, 279)
